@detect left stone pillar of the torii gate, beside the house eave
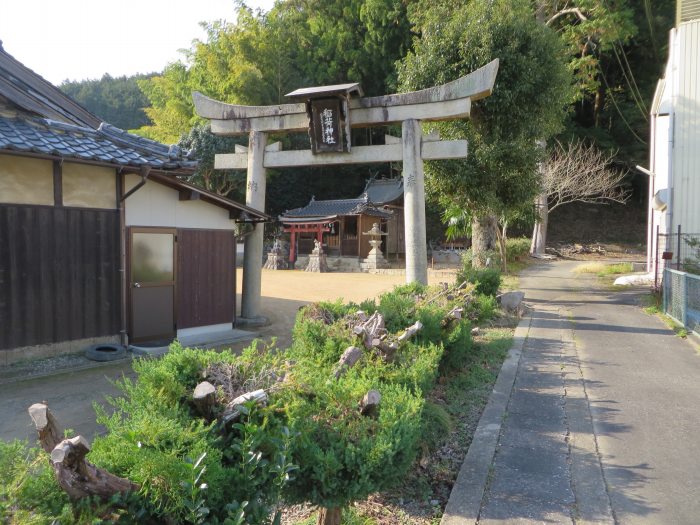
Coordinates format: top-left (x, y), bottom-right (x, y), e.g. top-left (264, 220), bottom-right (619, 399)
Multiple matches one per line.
top-left (241, 131), bottom-right (267, 321)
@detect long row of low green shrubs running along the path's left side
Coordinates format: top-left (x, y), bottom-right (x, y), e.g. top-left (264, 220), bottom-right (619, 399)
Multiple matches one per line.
top-left (0, 285), bottom-right (504, 525)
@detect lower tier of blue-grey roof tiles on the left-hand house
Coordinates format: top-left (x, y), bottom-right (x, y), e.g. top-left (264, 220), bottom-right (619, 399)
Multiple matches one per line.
top-left (0, 117), bottom-right (196, 169)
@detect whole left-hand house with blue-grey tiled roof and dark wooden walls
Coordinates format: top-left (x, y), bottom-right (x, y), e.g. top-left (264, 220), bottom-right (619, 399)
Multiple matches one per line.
top-left (0, 42), bottom-right (268, 366)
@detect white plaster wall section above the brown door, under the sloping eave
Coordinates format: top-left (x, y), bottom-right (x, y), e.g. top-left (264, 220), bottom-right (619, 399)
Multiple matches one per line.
top-left (125, 175), bottom-right (234, 230)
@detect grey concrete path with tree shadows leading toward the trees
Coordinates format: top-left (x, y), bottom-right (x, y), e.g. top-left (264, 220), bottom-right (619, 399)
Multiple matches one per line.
top-left (443, 262), bottom-right (700, 525)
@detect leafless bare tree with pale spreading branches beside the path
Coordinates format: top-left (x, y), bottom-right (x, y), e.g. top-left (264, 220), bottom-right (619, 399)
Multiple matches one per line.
top-left (530, 141), bottom-right (629, 255)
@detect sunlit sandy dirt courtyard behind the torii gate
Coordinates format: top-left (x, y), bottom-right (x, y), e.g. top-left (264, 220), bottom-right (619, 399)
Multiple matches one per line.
top-left (243, 270), bottom-right (455, 348)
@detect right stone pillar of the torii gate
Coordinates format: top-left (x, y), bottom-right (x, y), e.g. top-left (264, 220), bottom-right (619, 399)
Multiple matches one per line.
top-left (401, 119), bottom-right (428, 284)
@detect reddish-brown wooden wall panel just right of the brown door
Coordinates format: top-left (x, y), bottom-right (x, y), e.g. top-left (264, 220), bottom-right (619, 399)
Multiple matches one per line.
top-left (177, 229), bottom-right (236, 328)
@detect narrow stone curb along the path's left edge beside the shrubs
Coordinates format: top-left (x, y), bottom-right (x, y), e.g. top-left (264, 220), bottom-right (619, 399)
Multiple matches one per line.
top-left (440, 315), bottom-right (532, 525)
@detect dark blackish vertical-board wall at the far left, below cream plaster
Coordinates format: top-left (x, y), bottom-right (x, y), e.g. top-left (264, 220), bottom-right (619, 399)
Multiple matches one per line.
top-left (0, 204), bottom-right (120, 350)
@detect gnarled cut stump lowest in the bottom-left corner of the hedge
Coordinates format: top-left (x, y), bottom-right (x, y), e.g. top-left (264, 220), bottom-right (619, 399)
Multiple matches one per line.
top-left (51, 436), bottom-right (139, 500)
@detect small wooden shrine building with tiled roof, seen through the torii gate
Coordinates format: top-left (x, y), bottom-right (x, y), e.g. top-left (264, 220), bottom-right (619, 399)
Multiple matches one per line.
top-left (279, 178), bottom-right (406, 263)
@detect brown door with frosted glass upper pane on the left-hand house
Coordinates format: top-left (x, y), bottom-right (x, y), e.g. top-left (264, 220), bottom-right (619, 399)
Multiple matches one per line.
top-left (129, 228), bottom-right (177, 342)
